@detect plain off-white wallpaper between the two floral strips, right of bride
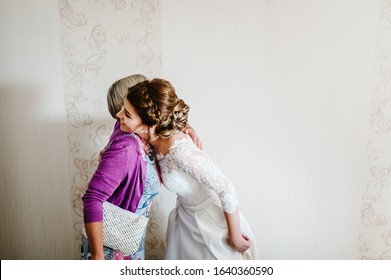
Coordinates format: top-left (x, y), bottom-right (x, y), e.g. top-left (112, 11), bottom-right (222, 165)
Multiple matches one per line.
top-left (162, 0), bottom-right (391, 259)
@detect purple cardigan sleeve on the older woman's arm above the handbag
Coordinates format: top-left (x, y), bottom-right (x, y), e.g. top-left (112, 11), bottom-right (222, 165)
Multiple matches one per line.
top-left (82, 142), bottom-right (135, 223)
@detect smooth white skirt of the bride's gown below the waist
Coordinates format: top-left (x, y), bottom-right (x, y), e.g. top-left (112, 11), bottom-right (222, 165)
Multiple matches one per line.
top-left (165, 196), bottom-right (258, 260)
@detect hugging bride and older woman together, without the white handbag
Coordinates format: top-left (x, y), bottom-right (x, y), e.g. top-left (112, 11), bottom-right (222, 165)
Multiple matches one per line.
top-left (81, 75), bottom-right (258, 260)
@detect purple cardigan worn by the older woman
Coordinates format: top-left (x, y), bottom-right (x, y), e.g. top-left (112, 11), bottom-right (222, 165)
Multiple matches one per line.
top-left (82, 121), bottom-right (146, 223)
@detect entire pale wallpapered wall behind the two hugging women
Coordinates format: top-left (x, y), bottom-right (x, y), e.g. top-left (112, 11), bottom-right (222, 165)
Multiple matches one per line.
top-left (0, 0), bottom-right (391, 259)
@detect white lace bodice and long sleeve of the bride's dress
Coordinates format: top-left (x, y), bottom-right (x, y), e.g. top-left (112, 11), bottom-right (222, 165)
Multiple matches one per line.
top-left (157, 138), bottom-right (238, 213)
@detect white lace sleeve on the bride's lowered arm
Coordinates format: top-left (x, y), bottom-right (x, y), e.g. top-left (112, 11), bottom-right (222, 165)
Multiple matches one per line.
top-left (170, 139), bottom-right (239, 213)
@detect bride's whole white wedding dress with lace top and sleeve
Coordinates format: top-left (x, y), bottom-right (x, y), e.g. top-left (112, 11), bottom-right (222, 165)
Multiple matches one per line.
top-left (157, 138), bottom-right (258, 260)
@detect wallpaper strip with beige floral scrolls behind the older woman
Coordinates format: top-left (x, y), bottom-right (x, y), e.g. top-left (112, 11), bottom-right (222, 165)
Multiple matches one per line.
top-left (58, 0), bottom-right (165, 259)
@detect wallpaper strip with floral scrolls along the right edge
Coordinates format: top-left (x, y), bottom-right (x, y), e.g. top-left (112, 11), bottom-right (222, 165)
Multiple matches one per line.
top-left (359, 0), bottom-right (391, 260)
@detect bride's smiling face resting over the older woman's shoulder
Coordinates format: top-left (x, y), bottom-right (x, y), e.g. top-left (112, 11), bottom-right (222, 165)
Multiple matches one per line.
top-left (116, 97), bottom-right (148, 134)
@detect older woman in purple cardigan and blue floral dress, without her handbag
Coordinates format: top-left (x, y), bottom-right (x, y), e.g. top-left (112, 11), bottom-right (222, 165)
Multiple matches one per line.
top-left (81, 75), bottom-right (160, 260)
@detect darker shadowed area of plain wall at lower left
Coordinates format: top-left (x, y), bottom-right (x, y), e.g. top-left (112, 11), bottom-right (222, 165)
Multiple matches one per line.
top-left (0, 86), bottom-right (75, 259)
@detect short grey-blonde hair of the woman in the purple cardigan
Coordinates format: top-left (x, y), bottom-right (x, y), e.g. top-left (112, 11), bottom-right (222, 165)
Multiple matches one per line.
top-left (107, 74), bottom-right (148, 118)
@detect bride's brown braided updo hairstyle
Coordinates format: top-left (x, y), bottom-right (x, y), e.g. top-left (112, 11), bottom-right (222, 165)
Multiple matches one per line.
top-left (126, 78), bottom-right (190, 138)
